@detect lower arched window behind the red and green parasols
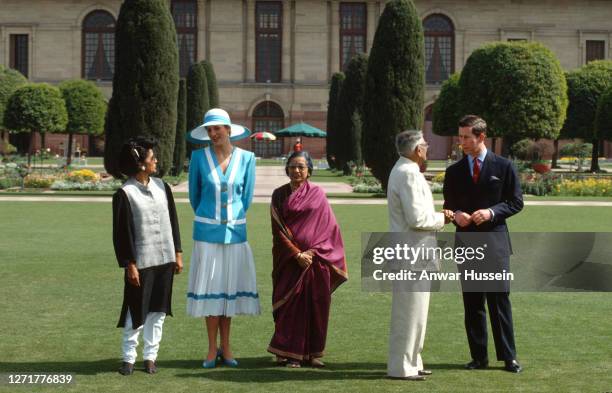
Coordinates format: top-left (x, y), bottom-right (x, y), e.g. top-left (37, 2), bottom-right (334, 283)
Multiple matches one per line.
top-left (252, 101), bottom-right (285, 157)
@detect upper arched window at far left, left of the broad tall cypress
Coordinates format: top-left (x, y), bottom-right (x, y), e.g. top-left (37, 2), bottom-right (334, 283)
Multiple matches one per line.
top-left (83, 10), bottom-right (115, 80)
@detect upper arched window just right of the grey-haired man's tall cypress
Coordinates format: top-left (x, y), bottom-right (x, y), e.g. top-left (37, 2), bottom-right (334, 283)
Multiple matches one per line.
top-left (423, 14), bottom-right (455, 84)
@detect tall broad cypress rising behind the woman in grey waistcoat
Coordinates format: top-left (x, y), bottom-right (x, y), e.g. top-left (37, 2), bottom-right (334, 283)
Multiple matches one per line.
top-left (104, 0), bottom-right (179, 177)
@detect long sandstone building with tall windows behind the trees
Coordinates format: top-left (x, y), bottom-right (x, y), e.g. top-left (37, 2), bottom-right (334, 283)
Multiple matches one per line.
top-left (0, 0), bottom-right (612, 158)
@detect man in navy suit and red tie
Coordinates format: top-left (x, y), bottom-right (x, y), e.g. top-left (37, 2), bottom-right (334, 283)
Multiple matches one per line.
top-left (444, 115), bottom-right (523, 373)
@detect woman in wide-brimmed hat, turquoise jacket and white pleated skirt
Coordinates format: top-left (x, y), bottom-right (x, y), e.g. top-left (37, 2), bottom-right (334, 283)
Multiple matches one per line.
top-left (187, 109), bottom-right (260, 368)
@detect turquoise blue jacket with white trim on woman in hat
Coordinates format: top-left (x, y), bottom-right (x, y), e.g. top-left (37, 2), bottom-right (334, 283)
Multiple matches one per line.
top-left (189, 147), bottom-right (255, 244)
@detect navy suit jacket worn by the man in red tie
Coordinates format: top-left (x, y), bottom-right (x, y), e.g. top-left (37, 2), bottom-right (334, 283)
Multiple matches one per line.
top-left (443, 151), bottom-right (523, 255)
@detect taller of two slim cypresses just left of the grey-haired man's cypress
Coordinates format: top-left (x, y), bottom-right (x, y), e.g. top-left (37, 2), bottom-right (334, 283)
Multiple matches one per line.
top-left (336, 54), bottom-right (368, 168)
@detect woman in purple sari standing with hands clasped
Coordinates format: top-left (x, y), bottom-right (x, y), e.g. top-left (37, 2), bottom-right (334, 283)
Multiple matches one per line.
top-left (268, 152), bottom-right (348, 367)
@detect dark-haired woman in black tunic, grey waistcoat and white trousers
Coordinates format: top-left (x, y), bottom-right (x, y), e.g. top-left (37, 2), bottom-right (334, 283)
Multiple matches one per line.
top-left (113, 138), bottom-right (183, 375)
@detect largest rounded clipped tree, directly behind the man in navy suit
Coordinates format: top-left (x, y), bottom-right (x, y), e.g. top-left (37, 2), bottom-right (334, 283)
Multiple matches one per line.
top-left (459, 42), bottom-right (568, 148)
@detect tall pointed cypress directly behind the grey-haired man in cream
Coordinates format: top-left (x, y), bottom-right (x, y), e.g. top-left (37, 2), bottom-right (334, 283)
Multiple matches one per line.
top-left (363, 0), bottom-right (425, 189)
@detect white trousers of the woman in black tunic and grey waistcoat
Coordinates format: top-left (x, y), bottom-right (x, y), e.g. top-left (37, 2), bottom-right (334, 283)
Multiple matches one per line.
top-left (122, 310), bottom-right (166, 364)
